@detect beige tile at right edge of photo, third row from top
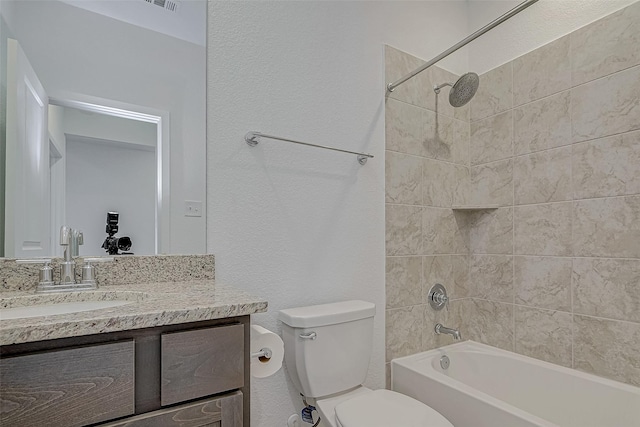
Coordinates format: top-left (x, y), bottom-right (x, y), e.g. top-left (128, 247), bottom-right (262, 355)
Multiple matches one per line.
top-left (572, 132), bottom-right (640, 199)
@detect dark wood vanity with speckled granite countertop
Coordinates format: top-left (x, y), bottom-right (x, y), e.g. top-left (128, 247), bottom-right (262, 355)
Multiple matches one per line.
top-left (0, 260), bottom-right (267, 427)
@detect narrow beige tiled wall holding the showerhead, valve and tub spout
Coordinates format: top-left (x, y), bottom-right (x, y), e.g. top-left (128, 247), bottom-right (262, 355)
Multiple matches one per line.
top-left (385, 46), bottom-right (470, 384)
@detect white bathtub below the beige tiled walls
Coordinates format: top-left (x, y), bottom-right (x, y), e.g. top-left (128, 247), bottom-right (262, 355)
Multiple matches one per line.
top-left (391, 341), bottom-right (640, 427)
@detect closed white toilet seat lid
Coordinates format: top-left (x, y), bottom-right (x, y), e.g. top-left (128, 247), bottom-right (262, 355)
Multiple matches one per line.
top-left (335, 390), bottom-right (453, 427)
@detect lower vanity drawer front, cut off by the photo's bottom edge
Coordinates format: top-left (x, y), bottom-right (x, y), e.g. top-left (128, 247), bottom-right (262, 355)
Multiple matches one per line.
top-left (100, 391), bottom-right (242, 427)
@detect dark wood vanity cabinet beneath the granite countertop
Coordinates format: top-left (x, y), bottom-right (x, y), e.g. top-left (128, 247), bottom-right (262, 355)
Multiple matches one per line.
top-left (0, 316), bottom-right (250, 427)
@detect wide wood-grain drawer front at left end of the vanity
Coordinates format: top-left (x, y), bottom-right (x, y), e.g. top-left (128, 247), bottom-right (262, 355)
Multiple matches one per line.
top-left (0, 340), bottom-right (134, 427)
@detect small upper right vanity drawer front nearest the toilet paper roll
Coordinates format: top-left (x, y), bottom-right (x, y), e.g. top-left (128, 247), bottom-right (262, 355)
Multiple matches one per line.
top-left (160, 324), bottom-right (244, 406)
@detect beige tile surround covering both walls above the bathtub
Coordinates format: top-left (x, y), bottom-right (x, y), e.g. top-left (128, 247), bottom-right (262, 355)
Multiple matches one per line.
top-left (386, 2), bottom-right (640, 385)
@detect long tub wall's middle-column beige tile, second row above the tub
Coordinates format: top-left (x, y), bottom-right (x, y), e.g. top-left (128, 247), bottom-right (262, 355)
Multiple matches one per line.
top-left (514, 256), bottom-right (571, 311)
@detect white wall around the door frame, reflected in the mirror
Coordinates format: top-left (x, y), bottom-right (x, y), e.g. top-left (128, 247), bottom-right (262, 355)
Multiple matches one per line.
top-left (2, 0), bottom-right (206, 253)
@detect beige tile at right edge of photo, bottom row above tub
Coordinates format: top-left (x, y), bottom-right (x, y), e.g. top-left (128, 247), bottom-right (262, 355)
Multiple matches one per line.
top-left (573, 315), bottom-right (640, 387)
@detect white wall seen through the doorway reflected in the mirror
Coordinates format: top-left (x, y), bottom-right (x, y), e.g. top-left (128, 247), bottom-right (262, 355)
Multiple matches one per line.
top-left (66, 139), bottom-right (155, 256)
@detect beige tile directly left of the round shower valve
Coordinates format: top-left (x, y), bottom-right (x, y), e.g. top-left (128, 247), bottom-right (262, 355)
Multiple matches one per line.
top-left (385, 257), bottom-right (422, 308)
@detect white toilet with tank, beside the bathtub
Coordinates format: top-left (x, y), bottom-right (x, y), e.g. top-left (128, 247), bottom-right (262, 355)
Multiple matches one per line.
top-left (279, 301), bottom-right (453, 427)
